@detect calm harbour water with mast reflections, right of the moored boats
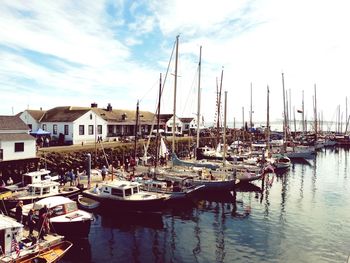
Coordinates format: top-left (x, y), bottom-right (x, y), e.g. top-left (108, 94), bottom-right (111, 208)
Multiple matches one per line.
top-left (62, 149), bottom-right (350, 262)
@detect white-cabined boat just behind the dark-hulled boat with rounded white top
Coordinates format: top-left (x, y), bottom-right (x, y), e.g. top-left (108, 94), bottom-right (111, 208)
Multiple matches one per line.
top-left (3, 180), bottom-right (80, 209)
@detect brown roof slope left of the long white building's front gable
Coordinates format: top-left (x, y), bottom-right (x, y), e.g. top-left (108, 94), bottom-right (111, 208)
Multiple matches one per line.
top-left (41, 106), bottom-right (90, 122)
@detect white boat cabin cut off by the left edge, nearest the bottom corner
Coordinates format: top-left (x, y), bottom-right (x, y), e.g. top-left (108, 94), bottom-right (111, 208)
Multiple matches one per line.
top-left (0, 214), bottom-right (23, 255)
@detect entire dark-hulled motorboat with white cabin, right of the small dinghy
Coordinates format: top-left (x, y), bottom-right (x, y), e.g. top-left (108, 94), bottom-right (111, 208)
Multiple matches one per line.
top-left (83, 180), bottom-right (169, 212)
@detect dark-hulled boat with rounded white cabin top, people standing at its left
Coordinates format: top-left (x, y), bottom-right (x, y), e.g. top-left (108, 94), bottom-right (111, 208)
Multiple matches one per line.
top-left (15, 196), bottom-right (93, 237)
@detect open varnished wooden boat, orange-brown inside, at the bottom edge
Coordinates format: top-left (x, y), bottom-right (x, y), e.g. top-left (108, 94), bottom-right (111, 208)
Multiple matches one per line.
top-left (19, 240), bottom-right (73, 263)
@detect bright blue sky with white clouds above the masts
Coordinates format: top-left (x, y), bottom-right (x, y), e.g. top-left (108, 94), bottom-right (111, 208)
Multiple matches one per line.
top-left (0, 0), bottom-right (350, 128)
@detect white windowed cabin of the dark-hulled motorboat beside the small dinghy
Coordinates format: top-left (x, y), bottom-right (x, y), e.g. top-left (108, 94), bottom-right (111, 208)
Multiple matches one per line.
top-left (100, 181), bottom-right (140, 198)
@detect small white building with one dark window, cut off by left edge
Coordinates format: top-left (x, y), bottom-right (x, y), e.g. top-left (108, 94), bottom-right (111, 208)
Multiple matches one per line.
top-left (0, 116), bottom-right (36, 162)
